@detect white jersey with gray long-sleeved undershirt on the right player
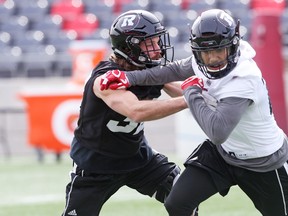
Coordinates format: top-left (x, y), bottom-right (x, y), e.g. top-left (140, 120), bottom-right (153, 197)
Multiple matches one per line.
top-left (126, 41), bottom-right (288, 172)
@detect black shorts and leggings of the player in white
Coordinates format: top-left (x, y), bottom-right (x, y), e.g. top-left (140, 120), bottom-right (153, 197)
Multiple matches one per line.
top-left (165, 141), bottom-right (288, 216)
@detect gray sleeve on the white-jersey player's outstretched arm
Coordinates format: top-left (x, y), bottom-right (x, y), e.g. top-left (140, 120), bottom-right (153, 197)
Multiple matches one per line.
top-left (125, 57), bottom-right (194, 85)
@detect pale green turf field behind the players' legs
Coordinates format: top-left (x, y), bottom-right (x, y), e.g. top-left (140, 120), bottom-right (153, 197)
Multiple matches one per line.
top-left (0, 155), bottom-right (260, 216)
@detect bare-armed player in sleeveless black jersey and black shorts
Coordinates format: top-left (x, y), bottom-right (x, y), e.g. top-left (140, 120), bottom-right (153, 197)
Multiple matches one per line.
top-left (62, 10), bottom-right (187, 216)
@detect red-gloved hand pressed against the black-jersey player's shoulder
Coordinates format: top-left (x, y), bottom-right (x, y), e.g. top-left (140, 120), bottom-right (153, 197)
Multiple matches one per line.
top-left (100, 70), bottom-right (130, 91)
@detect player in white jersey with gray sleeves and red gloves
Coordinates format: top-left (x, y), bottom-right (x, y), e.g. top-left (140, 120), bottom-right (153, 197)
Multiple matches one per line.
top-left (101, 9), bottom-right (288, 216)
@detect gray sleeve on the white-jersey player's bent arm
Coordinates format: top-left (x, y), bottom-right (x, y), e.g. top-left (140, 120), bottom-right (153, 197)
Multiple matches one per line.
top-left (184, 87), bottom-right (252, 145)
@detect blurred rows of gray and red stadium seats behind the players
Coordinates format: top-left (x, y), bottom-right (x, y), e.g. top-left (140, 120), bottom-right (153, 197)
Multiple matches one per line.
top-left (0, 0), bottom-right (288, 78)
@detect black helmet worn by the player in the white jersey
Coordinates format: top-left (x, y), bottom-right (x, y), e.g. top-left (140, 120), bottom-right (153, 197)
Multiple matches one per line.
top-left (190, 9), bottom-right (240, 79)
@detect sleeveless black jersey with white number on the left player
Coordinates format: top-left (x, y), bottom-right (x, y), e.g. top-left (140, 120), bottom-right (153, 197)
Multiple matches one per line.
top-left (70, 61), bottom-right (163, 173)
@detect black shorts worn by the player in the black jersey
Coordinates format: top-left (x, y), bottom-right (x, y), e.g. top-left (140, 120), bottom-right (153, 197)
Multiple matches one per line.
top-left (63, 153), bottom-right (180, 216)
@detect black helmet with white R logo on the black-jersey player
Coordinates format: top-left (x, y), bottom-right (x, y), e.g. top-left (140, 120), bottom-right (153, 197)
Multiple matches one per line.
top-left (110, 10), bottom-right (174, 68)
